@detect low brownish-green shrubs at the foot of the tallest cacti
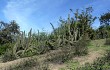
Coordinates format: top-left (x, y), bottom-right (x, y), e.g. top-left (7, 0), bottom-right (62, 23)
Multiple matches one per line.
top-left (49, 39), bottom-right (89, 63)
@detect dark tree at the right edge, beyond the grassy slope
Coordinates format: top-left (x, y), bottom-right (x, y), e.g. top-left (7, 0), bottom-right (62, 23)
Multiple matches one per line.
top-left (99, 12), bottom-right (110, 38)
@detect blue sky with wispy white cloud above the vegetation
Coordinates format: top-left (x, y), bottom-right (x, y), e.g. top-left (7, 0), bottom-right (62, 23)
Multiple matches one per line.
top-left (0, 0), bottom-right (110, 32)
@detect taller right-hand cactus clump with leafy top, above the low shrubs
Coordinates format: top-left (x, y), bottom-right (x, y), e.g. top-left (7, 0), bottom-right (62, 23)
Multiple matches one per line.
top-left (49, 7), bottom-right (93, 53)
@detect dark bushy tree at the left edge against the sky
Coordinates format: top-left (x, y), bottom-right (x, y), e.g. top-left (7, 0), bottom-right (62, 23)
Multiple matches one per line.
top-left (0, 20), bottom-right (20, 44)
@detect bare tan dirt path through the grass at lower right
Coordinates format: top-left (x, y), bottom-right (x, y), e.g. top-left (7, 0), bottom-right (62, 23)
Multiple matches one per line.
top-left (50, 50), bottom-right (105, 70)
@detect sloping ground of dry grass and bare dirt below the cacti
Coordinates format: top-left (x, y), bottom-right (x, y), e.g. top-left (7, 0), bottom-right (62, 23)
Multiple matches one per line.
top-left (0, 39), bottom-right (110, 70)
